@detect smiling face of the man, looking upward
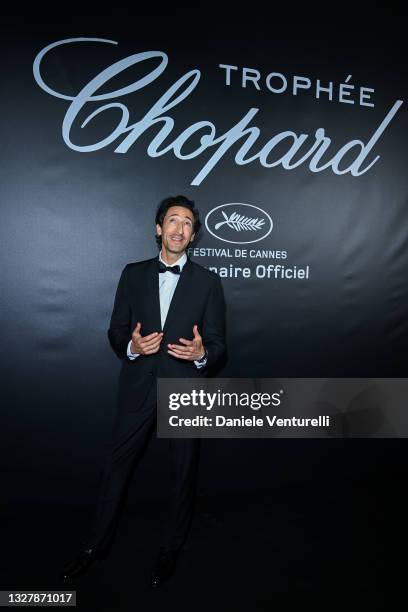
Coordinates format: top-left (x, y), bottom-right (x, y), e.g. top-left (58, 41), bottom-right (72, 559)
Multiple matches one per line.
top-left (156, 206), bottom-right (194, 256)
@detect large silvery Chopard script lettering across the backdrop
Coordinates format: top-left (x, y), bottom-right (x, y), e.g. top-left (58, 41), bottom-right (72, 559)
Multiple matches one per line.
top-left (33, 38), bottom-right (402, 185)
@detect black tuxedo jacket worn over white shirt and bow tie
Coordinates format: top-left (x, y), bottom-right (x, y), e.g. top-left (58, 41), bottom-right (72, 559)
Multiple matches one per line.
top-left (108, 257), bottom-right (226, 412)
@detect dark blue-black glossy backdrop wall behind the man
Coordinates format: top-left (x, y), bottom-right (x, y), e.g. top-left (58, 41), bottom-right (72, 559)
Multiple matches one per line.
top-left (0, 17), bottom-right (408, 502)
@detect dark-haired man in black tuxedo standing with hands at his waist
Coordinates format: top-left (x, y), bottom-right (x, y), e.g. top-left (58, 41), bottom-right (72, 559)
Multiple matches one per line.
top-left (63, 196), bottom-right (226, 587)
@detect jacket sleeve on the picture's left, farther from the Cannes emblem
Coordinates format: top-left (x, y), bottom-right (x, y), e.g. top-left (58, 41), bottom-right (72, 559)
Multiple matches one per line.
top-left (108, 266), bottom-right (132, 359)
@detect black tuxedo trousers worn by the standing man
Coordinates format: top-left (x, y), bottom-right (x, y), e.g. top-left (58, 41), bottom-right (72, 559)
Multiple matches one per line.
top-left (86, 384), bottom-right (199, 551)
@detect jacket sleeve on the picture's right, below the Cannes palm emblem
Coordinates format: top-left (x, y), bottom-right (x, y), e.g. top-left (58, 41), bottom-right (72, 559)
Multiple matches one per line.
top-left (201, 274), bottom-right (226, 370)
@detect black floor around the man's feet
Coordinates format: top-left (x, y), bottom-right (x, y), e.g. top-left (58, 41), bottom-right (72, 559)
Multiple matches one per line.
top-left (0, 482), bottom-right (396, 612)
